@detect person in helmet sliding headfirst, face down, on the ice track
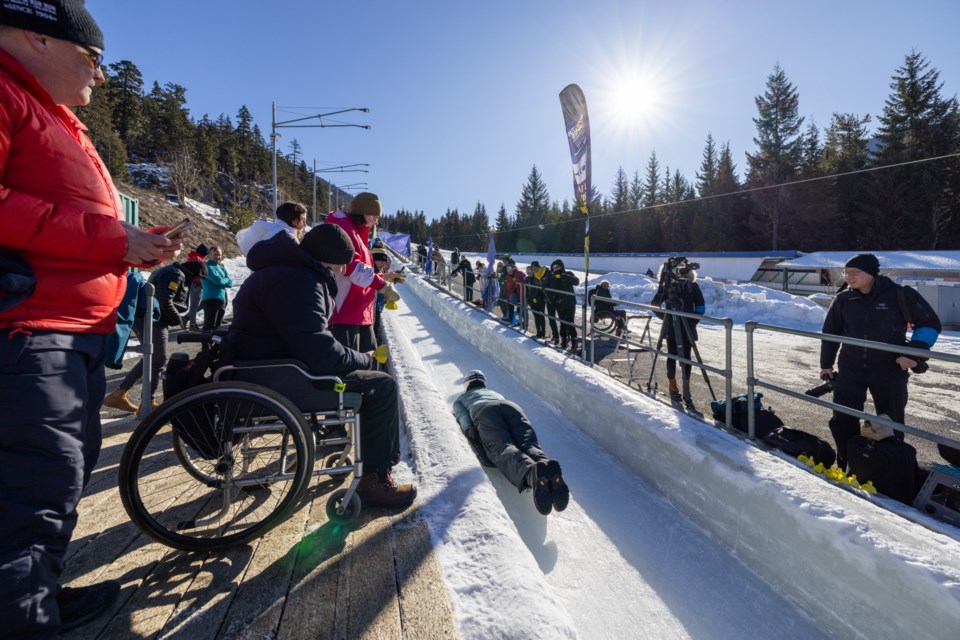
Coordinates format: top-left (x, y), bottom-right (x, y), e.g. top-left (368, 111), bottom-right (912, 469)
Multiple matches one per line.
top-left (453, 371), bottom-right (570, 516)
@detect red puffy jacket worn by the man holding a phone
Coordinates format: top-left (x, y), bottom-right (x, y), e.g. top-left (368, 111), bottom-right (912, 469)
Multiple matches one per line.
top-left (0, 49), bottom-right (127, 333)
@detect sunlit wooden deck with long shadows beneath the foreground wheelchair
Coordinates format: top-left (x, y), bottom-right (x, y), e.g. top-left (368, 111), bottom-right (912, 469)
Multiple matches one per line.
top-left (62, 344), bottom-right (457, 640)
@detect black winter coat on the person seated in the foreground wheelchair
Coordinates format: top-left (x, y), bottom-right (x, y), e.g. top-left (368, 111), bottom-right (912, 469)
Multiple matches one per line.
top-left (227, 233), bottom-right (376, 375)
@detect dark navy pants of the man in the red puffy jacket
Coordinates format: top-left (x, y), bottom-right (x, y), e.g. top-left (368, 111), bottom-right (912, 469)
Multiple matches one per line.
top-left (0, 329), bottom-right (106, 638)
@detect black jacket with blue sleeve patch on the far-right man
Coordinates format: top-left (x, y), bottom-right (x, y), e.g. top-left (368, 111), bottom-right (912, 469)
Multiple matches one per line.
top-left (820, 276), bottom-right (941, 369)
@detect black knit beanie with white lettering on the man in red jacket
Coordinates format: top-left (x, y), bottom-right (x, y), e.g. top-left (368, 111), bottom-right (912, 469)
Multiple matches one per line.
top-left (0, 0), bottom-right (103, 50)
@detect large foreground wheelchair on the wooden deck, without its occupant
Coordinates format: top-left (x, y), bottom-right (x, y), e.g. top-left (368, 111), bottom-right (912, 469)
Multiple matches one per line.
top-left (119, 332), bottom-right (363, 552)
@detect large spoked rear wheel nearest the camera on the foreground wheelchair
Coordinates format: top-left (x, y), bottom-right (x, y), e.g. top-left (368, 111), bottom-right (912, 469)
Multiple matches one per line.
top-left (119, 382), bottom-right (315, 551)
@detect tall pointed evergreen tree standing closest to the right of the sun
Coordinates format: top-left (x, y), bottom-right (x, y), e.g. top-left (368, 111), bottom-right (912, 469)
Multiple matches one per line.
top-left (747, 63), bottom-right (803, 250)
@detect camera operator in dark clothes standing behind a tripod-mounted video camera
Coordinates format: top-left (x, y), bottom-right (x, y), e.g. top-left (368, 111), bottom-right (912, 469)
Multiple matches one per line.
top-left (650, 257), bottom-right (706, 409)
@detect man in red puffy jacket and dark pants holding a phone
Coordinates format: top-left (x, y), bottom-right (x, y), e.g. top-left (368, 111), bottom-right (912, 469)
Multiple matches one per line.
top-left (0, 0), bottom-right (187, 638)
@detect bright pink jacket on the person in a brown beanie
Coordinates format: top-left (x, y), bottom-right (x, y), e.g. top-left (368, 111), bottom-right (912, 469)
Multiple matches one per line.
top-left (324, 211), bottom-right (384, 325)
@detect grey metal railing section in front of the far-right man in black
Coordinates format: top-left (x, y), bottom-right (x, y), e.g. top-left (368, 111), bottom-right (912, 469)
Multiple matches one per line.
top-left (744, 321), bottom-right (960, 448)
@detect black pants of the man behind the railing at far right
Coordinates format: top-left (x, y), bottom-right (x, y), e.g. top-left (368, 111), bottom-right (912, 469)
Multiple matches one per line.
top-left (830, 363), bottom-right (910, 469)
